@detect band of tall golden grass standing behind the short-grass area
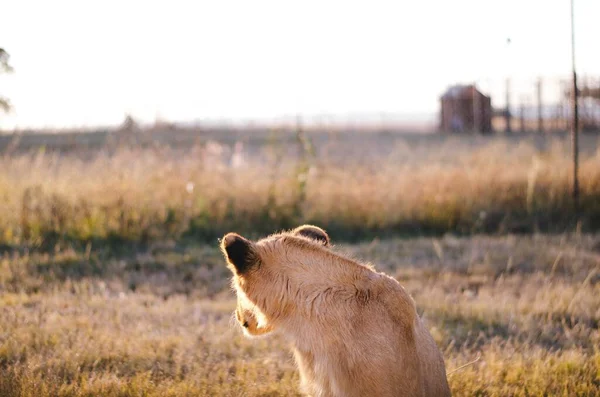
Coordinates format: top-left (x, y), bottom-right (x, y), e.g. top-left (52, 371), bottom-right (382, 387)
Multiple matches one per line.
top-left (0, 140), bottom-right (600, 246)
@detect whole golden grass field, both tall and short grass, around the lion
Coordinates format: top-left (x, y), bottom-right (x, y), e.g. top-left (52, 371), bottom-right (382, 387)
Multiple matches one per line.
top-left (0, 133), bottom-right (600, 397)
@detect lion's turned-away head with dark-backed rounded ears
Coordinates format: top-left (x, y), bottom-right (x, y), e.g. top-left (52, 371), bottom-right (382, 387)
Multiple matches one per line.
top-left (221, 225), bottom-right (330, 336)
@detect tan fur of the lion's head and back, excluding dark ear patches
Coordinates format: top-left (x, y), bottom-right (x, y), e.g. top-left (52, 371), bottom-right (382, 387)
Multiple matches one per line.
top-left (222, 226), bottom-right (450, 397)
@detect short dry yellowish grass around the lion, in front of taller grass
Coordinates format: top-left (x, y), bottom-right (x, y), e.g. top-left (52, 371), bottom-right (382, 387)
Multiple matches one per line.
top-left (0, 235), bottom-right (600, 397)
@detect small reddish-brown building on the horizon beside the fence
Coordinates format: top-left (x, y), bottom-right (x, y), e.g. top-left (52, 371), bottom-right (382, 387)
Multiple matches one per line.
top-left (440, 85), bottom-right (492, 132)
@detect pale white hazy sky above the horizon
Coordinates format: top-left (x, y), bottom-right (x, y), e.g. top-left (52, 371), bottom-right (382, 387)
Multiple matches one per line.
top-left (0, 0), bottom-right (600, 128)
